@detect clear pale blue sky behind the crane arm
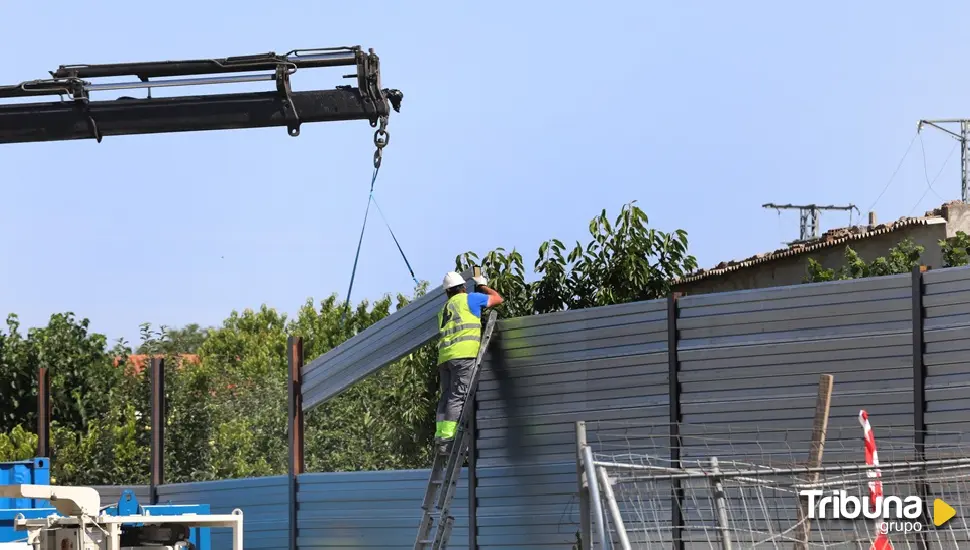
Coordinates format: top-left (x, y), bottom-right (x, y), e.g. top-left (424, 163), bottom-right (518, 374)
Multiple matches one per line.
top-left (0, 0), bottom-right (970, 350)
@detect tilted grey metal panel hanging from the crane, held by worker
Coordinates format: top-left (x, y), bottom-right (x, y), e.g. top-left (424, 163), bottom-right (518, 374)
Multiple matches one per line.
top-left (302, 270), bottom-right (473, 410)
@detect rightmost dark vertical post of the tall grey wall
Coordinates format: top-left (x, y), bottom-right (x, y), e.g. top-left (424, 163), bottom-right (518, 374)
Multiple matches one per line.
top-left (912, 266), bottom-right (928, 550)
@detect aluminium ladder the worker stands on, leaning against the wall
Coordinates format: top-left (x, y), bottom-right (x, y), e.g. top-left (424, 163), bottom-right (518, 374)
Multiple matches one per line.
top-left (414, 311), bottom-right (496, 550)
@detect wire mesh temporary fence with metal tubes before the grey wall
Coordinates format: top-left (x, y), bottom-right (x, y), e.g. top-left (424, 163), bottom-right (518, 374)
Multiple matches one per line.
top-left (585, 419), bottom-right (970, 550)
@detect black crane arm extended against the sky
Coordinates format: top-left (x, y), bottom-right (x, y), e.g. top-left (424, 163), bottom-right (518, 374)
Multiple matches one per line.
top-left (0, 46), bottom-right (403, 143)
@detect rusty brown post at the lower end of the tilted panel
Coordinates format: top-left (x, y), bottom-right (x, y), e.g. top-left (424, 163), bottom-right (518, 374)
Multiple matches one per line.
top-left (286, 336), bottom-right (306, 550)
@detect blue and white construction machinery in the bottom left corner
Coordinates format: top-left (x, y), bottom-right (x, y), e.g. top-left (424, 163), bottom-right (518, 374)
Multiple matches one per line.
top-left (0, 457), bottom-right (233, 550)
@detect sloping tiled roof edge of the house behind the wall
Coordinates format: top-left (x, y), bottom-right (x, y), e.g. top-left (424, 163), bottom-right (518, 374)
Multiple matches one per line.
top-left (673, 201), bottom-right (959, 285)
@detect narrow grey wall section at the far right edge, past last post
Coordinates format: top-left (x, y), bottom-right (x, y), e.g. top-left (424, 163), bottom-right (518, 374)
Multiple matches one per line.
top-left (923, 267), bottom-right (970, 458)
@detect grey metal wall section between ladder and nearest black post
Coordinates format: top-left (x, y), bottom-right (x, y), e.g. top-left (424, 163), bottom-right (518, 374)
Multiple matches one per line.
top-left (476, 300), bottom-right (669, 549)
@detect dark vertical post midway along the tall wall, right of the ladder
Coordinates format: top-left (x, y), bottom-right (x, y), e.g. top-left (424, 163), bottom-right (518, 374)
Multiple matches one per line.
top-left (667, 292), bottom-right (684, 550)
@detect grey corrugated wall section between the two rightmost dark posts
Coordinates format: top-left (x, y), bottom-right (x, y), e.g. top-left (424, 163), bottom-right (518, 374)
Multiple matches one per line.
top-left (677, 275), bottom-right (913, 468)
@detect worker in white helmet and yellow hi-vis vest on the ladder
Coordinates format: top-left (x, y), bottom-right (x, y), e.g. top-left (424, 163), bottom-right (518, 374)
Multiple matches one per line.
top-left (434, 271), bottom-right (504, 453)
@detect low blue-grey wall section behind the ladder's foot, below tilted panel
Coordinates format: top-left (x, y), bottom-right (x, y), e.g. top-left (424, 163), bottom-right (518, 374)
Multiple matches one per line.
top-left (297, 470), bottom-right (468, 550)
